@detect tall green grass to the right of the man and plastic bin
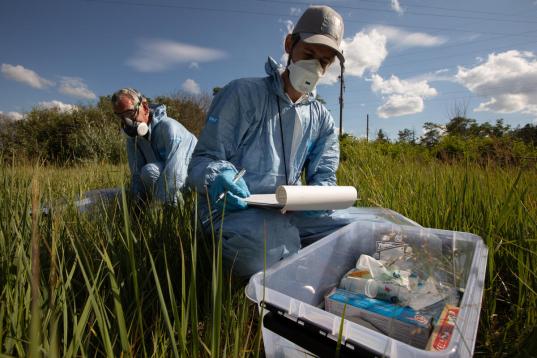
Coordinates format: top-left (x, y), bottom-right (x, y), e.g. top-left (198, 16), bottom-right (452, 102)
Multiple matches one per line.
top-left (338, 141), bottom-right (537, 356)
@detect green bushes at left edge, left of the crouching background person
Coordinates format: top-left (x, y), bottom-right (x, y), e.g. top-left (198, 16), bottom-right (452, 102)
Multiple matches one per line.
top-left (0, 101), bottom-right (125, 165)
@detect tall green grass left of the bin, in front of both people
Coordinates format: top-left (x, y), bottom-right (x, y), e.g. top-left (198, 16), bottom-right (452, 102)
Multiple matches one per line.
top-left (0, 166), bottom-right (257, 357)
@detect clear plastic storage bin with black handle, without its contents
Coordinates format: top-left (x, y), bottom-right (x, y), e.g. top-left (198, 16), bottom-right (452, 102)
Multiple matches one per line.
top-left (246, 221), bottom-right (488, 358)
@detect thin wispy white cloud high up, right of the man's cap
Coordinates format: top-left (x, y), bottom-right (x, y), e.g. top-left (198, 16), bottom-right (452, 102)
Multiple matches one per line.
top-left (370, 25), bottom-right (447, 48)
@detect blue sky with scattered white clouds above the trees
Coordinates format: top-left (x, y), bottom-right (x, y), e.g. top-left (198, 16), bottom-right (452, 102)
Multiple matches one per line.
top-left (0, 0), bottom-right (537, 138)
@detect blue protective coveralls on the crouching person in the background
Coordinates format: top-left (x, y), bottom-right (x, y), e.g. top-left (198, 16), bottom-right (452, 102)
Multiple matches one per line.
top-left (127, 105), bottom-right (197, 205)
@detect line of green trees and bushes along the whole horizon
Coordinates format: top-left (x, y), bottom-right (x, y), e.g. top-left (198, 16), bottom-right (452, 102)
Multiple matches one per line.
top-left (0, 93), bottom-right (537, 165)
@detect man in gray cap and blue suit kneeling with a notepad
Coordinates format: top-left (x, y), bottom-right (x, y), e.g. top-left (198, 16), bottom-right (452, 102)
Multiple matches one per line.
top-left (188, 6), bottom-right (408, 276)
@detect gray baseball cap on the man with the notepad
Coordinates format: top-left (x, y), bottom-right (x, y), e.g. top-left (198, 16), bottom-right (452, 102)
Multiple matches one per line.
top-left (293, 6), bottom-right (345, 63)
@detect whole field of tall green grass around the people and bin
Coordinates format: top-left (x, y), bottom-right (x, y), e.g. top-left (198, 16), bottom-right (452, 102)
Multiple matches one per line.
top-left (0, 140), bottom-right (537, 357)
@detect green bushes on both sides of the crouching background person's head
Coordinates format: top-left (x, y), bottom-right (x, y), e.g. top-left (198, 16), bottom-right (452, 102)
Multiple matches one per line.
top-left (0, 94), bottom-right (210, 165)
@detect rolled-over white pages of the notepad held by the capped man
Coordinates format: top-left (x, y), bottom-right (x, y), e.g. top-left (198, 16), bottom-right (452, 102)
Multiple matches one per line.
top-left (276, 185), bottom-right (358, 211)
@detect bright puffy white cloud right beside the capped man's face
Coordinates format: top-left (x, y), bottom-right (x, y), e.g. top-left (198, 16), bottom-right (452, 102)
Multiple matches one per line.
top-left (321, 29), bottom-right (388, 84)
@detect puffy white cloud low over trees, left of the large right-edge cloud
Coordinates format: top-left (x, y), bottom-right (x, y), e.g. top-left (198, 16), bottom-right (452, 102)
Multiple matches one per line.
top-left (371, 74), bottom-right (438, 118)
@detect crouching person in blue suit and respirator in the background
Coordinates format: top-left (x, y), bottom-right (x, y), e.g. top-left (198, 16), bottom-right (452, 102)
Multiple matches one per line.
top-left (112, 88), bottom-right (197, 205)
